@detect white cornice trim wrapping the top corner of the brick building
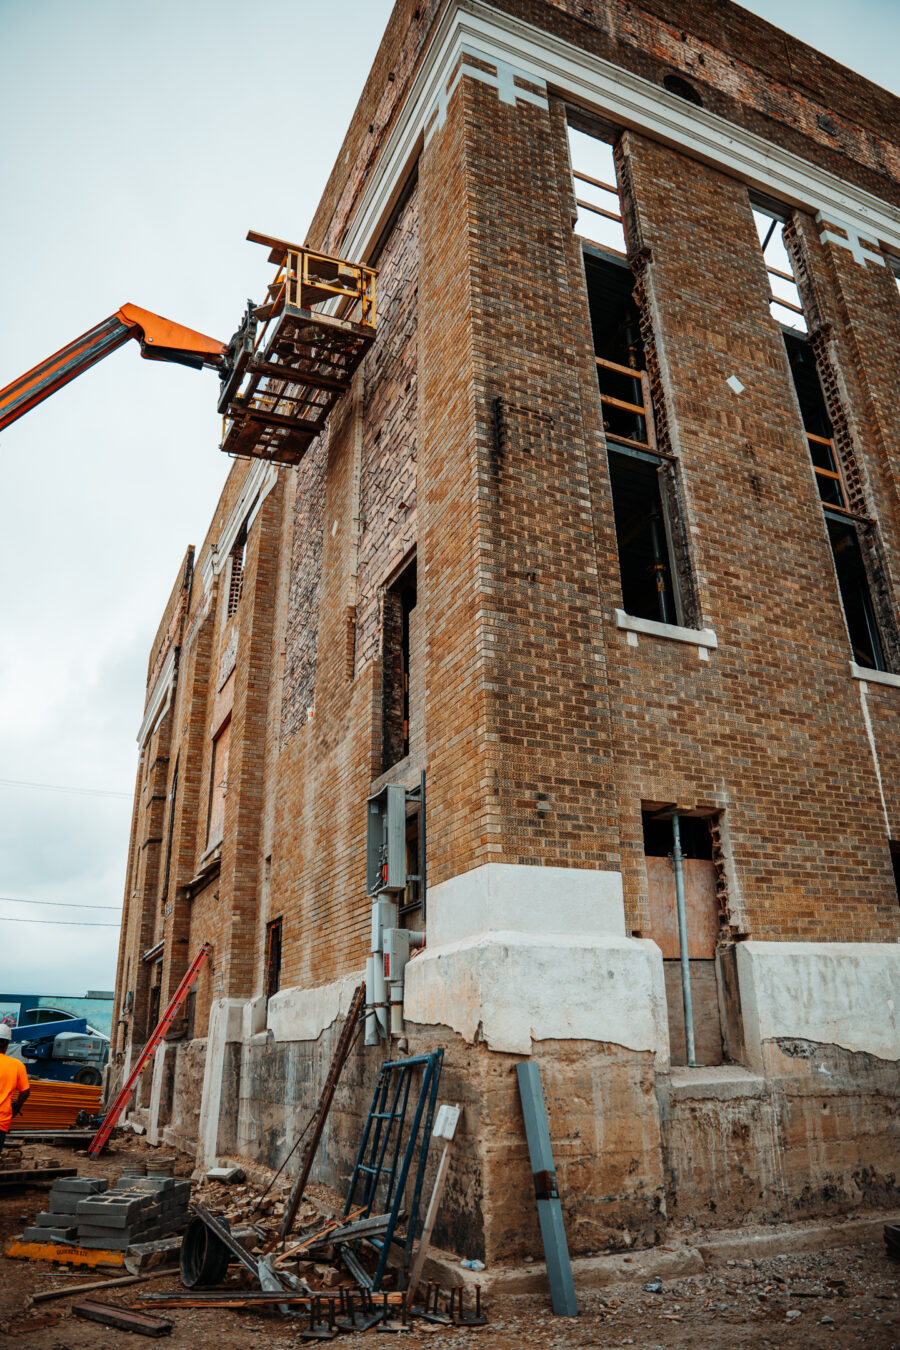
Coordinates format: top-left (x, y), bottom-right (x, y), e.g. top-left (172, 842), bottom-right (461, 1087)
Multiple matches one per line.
top-left (341, 0), bottom-right (900, 261)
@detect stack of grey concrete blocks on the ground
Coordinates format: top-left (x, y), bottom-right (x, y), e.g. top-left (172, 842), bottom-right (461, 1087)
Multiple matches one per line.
top-left (23, 1175), bottom-right (190, 1251)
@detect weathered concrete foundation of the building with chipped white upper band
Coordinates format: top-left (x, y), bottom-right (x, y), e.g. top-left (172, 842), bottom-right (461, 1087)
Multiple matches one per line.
top-left (126, 933), bottom-right (900, 1264)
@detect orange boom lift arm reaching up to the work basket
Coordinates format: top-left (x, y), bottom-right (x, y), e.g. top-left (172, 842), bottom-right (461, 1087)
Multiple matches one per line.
top-left (0, 305), bottom-right (225, 431)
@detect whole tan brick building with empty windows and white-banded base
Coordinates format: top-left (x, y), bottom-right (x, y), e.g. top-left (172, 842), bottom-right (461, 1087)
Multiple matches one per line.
top-left (116, 0), bottom-right (900, 1261)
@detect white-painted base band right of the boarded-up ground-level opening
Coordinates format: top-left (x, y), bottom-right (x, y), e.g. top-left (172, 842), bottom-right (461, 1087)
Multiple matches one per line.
top-left (737, 941), bottom-right (900, 1071)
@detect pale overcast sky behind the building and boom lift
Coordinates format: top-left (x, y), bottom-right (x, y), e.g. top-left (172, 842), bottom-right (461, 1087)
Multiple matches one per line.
top-left (0, 0), bottom-right (900, 995)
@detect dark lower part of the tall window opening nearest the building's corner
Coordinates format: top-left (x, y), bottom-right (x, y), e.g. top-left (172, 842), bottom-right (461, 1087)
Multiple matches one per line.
top-left (584, 252), bottom-right (680, 624)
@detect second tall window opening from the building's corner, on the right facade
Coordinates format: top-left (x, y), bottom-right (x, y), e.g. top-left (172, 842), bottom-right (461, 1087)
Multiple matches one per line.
top-left (753, 207), bottom-right (887, 670)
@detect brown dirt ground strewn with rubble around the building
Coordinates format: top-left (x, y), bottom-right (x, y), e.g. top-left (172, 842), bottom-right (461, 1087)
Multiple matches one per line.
top-left (0, 1139), bottom-right (900, 1350)
